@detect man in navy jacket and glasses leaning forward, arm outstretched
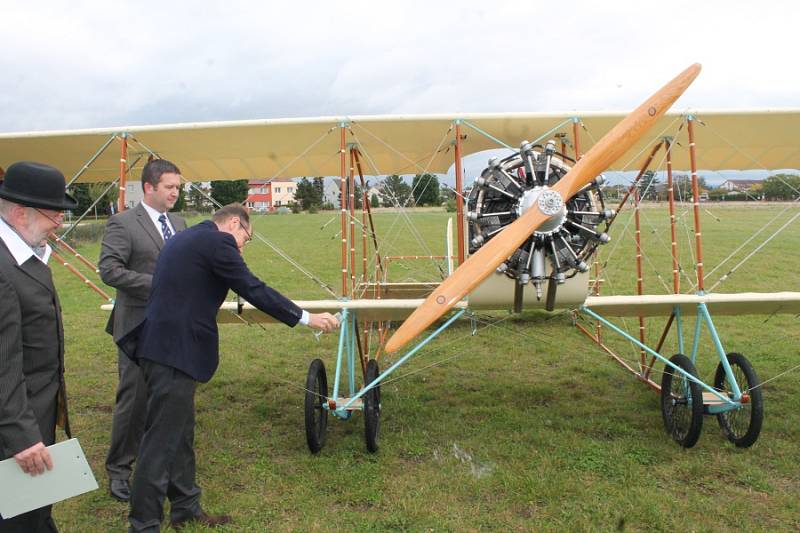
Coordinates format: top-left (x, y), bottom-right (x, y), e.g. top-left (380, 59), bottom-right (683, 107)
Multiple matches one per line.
top-left (119, 204), bottom-right (339, 531)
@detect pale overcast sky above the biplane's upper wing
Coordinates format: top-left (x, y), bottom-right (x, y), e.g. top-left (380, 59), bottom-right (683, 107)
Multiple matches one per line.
top-left (0, 0), bottom-right (800, 132)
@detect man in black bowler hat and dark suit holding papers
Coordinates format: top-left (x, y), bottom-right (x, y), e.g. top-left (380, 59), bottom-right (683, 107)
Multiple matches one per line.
top-left (0, 161), bottom-right (78, 533)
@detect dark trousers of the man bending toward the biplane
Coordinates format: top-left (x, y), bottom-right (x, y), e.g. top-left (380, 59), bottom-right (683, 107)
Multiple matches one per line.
top-left (128, 359), bottom-right (202, 532)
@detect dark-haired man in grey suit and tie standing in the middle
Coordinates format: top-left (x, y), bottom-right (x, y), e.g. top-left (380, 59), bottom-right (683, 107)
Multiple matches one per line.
top-left (98, 159), bottom-right (186, 501)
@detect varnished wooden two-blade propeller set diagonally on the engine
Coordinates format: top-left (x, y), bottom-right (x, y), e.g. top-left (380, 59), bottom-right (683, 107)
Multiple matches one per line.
top-left (386, 63), bottom-right (700, 353)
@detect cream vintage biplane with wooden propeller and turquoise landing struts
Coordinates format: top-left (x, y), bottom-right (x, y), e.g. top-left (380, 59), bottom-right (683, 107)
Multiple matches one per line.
top-left (0, 65), bottom-right (800, 453)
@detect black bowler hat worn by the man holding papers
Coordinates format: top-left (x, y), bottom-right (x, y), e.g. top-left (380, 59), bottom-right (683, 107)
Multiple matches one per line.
top-left (0, 161), bottom-right (78, 211)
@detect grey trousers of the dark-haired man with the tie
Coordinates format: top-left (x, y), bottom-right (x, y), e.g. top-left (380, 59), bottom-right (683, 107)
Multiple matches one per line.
top-left (106, 350), bottom-right (147, 480)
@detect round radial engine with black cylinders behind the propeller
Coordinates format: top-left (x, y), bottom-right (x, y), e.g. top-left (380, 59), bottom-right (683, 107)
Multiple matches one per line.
top-left (466, 140), bottom-right (615, 312)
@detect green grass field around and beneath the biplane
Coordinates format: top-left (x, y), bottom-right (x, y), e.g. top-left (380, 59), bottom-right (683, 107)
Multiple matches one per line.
top-left (54, 204), bottom-right (800, 532)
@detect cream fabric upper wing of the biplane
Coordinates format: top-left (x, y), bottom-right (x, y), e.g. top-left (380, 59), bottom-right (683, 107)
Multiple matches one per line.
top-left (0, 109), bottom-right (800, 181)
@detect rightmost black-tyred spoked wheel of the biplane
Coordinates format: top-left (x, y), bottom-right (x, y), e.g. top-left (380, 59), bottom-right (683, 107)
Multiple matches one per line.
top-left (714, 353), bottom-right (764, 448)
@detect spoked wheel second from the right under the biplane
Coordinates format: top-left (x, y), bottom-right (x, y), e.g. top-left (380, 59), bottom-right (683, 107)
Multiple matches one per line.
top-left (661, 354), bottom-right (703, 448)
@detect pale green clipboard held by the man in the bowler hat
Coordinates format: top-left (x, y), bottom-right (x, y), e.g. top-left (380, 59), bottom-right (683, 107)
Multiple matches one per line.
top-left (0, 439), bottom-right (97, 518)
